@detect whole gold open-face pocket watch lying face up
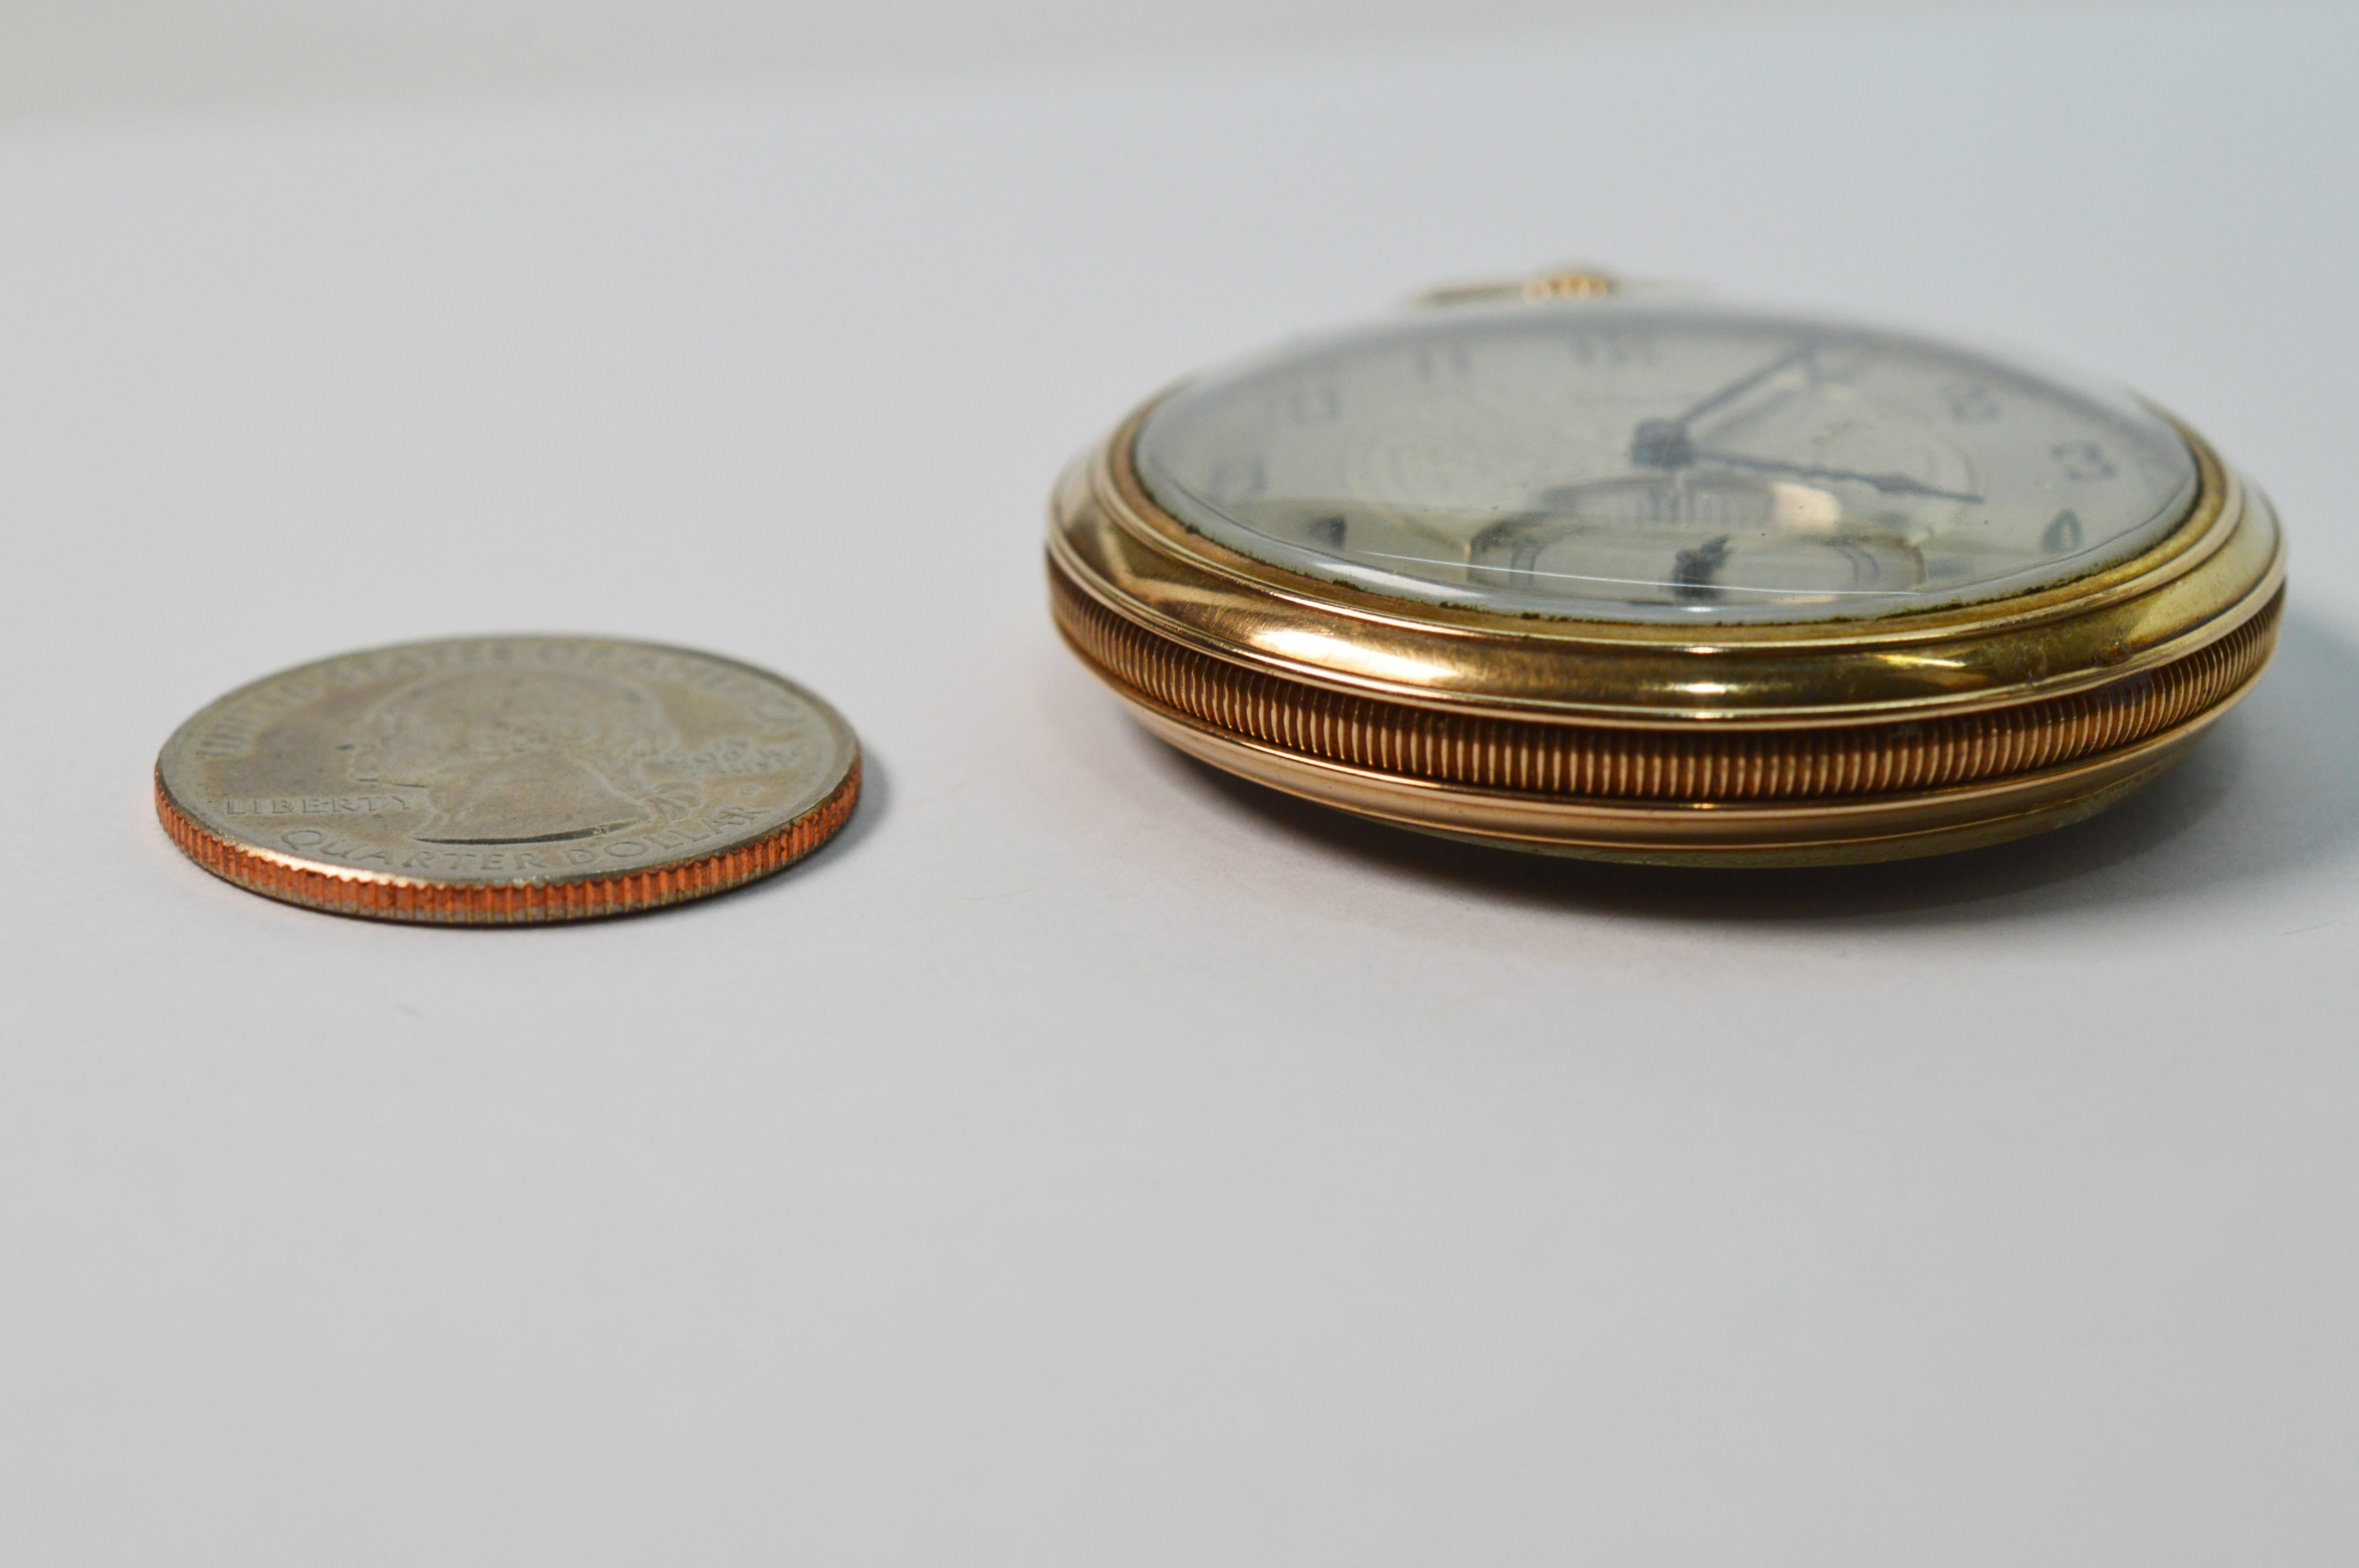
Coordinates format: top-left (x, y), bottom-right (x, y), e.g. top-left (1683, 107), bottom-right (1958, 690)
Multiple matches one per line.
top-left (1047, 271), bottom-right (2286, 866)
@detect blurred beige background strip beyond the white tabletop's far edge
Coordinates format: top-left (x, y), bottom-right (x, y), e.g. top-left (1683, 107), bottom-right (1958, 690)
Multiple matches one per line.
top-left (0, 0), bottom-right (1934, 123)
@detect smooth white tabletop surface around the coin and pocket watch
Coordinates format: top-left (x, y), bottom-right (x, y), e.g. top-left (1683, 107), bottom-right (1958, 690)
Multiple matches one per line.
top-left (0, 9), bottom-right (2359, 1568)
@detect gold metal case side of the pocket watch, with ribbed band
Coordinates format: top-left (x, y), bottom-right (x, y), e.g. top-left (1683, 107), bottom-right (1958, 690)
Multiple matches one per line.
top-left (1047, 387), bottom-right (2283, 866)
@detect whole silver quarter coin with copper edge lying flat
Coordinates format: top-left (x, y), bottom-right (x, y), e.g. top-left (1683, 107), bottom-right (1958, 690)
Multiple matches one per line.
top-left (156, 637), bottom-right (861, 924)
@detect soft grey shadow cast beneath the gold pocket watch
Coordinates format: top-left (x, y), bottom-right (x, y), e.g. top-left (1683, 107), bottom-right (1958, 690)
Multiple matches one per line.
top-left (1156, 611), bottom-right (2359, 922)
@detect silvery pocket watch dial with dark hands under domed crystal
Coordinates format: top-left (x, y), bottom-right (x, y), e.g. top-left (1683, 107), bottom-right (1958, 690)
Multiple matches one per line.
top-left (1135, 299), bottom-right (2196, 622)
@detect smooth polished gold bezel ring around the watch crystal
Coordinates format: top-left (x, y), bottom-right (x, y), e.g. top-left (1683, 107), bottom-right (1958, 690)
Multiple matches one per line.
top-left (1050, 389), bottom-right (2283, 726)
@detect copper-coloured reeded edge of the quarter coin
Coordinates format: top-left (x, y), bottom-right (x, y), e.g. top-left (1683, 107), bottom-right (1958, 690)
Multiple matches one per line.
top-left (156, 748), bottom-right (861, 924)
